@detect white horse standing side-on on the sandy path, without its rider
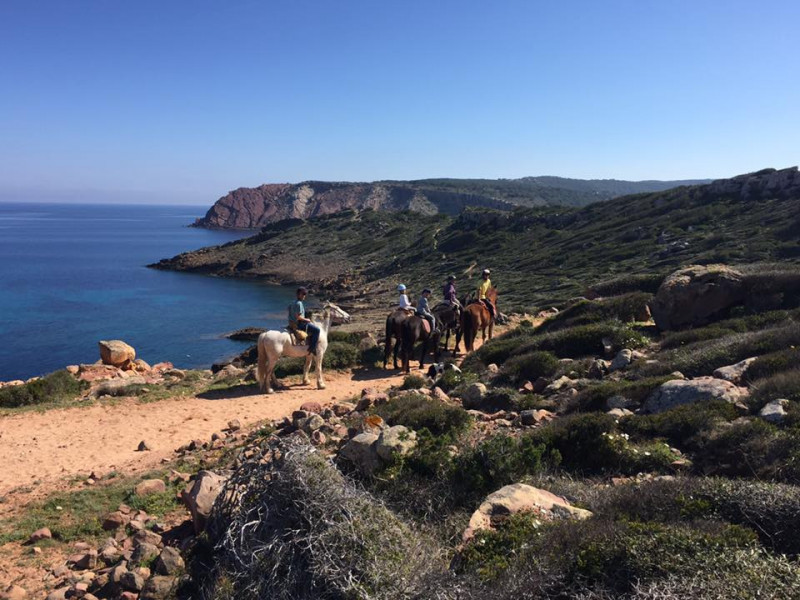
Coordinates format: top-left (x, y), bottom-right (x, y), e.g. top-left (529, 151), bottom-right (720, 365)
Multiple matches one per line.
top-left (257, 302), bottom-right (350, 394)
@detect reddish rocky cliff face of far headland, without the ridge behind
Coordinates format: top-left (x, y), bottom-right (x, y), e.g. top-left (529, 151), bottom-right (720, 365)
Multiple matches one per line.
top-left (194, 181), bottom-right (512, 229)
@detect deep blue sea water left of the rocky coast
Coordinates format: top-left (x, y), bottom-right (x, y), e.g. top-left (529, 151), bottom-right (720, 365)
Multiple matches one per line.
top-left (0, 203), bottom-right (293, 381)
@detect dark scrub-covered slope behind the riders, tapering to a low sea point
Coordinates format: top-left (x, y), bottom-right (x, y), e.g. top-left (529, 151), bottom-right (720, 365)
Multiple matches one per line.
top-left (152, 167), bottom-right (800, 308)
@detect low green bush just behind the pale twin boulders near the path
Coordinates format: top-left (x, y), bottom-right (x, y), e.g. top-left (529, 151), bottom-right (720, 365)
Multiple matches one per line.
top-left (374, 394), bottom-right (472, 435)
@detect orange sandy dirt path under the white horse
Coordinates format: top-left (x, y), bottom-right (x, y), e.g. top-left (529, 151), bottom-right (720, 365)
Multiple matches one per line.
top-left (0, 371), bottom-right (404, 495)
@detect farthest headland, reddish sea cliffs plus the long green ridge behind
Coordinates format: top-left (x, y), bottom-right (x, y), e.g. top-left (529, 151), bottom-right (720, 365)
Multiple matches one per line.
top-left (194, 177), bottom-right (705, 229)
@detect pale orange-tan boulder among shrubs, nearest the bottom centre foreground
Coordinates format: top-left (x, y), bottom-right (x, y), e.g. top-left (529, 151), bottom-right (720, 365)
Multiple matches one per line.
top-left (462, 483), bottom-right (592, 542)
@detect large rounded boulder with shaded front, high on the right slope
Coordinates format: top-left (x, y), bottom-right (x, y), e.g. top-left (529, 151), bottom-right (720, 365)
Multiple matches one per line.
top-left (650, 265), bottom-right (745, 331)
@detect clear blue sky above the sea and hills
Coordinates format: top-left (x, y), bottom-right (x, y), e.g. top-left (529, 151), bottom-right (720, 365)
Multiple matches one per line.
top-left (0, 0), bottom-right (800, 204)
